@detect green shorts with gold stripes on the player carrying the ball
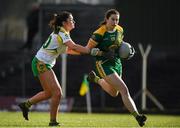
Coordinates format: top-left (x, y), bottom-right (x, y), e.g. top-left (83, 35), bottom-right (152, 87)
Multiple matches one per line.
top-left (96, 59), bottom-right (122, 78)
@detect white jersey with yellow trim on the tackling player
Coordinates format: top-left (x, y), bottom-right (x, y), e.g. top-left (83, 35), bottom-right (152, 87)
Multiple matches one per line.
top-left (36, 28), bottom-right (71, 67)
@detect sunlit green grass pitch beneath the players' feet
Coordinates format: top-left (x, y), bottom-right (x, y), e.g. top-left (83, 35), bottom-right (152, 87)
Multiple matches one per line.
top-left (0, 112), bottom-right (180, 128)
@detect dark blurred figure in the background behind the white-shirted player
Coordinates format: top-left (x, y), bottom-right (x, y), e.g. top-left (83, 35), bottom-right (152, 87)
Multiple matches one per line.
top-left (20, 3), bottom-right (39, 50)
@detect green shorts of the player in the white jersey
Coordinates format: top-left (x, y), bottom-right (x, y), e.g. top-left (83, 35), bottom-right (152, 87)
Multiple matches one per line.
top-left (31, 57), bottom-right (52, 76)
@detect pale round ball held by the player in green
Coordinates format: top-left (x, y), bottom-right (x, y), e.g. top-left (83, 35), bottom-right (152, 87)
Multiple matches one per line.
top-left (119, 41), bottom-right (135, 59)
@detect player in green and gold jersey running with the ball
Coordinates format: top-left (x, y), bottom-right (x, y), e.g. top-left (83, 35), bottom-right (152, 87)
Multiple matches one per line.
top-left (86, 9), bottom-right (146, 126)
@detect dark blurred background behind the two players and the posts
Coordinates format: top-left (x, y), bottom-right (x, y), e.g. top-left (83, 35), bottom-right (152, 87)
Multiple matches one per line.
top-left (0, 0), bottom-right (180, 113)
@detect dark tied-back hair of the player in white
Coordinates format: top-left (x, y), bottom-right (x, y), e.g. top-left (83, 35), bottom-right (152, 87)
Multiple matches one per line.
top-left (49, 11), bottom-right (72, 34)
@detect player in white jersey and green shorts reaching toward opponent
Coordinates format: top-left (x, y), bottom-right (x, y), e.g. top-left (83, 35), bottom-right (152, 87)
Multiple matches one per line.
top-left (19, 11), bottom-right (98, 126)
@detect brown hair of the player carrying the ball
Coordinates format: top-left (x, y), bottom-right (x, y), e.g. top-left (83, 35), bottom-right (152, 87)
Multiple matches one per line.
top-left (100, 9), bottom-right (120, 26)
